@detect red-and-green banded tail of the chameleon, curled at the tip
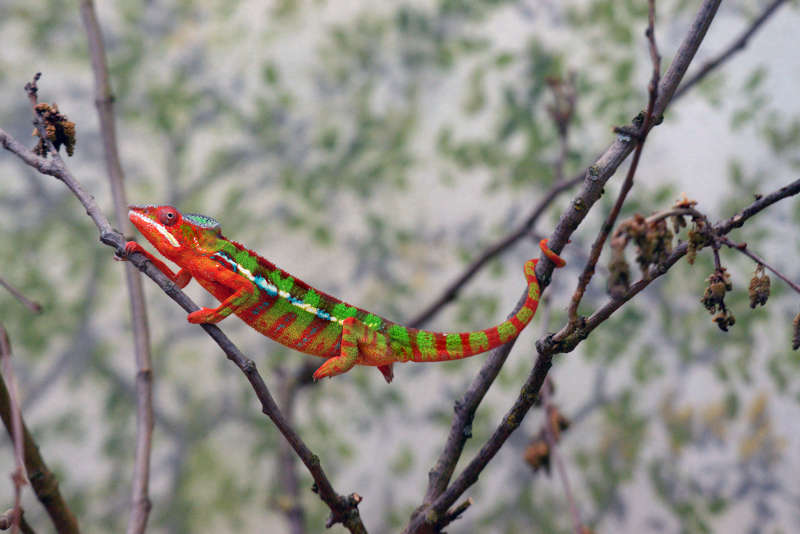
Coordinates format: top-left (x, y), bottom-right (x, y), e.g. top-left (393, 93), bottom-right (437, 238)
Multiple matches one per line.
top-left (410, 239), bottom-right (566, 362)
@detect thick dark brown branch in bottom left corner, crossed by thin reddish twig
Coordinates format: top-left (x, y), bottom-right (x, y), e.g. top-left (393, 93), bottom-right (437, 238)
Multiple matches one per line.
top-left (0, 350), bottom-right (80, 534)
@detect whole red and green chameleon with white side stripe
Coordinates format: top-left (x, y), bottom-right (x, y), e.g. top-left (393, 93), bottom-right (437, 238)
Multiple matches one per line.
top-left (121, 205), bottom-right (566, 382)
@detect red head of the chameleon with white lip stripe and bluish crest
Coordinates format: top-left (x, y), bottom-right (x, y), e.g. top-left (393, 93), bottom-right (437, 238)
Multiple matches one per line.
top-left (128, 205), bottom-right (219, 259)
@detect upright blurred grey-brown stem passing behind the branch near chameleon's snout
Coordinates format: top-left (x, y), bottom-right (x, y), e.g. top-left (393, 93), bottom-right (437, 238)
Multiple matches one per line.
top-left (80, 0), bottom-right (153, 534)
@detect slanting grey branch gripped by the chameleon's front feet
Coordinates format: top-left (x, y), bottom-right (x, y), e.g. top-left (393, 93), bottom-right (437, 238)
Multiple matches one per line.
top-left (0, 127), bottom-right (366, 533)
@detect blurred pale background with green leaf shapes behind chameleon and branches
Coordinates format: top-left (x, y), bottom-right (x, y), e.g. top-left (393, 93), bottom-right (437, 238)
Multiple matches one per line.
top-left (0, 0), bottom-right (800, 533)
